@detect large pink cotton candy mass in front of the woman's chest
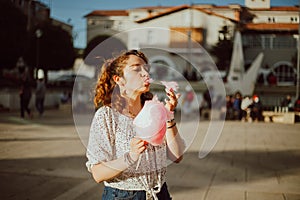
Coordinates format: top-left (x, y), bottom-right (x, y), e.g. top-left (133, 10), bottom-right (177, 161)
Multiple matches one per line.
top-left (133, 96), bottom-right (169, 146)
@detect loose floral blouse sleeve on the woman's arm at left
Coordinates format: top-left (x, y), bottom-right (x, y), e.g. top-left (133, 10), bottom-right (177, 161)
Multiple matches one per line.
top-left (86, 106), bottom-right (115, 172)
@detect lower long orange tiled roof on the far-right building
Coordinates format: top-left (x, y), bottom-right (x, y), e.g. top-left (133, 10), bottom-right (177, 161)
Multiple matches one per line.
top-left (243, 23), bottom-right (299, 31)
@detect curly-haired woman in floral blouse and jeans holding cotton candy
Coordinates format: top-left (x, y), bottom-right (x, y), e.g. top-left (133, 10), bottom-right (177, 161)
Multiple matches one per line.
top-left (86, 50), bottom-right (184, 200)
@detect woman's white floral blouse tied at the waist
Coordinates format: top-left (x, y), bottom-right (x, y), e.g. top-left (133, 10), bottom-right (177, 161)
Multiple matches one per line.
top-left (86, 106), bottom-right (167, 195)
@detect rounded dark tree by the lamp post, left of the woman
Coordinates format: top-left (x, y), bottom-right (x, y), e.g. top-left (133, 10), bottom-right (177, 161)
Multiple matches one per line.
top-left (25, 22), bottom-right (75, 79)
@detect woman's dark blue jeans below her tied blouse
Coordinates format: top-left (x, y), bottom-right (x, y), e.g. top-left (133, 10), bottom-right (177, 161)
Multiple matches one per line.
top-left (102, 183), bottom-right (172, 200)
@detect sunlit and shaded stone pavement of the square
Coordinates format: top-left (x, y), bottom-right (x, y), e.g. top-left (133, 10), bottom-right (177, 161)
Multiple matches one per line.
top-left (0, 109), bottom-right (300, 200)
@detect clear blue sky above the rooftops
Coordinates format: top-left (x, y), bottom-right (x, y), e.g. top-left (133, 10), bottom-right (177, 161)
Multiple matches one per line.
top-left (44, 0), bottom-right (300, 48)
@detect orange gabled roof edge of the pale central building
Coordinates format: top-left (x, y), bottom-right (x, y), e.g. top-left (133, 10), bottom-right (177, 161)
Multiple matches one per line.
top-left (136, 5), bottom-right (237, 23)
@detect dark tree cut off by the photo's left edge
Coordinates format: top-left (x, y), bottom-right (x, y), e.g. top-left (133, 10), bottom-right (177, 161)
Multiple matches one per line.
top-left (0, 0), bottom-right (27, 70)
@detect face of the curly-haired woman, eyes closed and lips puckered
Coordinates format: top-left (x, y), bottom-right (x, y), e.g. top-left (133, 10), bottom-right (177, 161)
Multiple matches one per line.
top-left (122, 55), bottom-right (150, 95)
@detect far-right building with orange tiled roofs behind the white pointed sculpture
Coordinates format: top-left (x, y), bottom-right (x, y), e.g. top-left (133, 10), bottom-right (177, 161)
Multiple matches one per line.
top-left (240, 0), bottom-right (299, 85)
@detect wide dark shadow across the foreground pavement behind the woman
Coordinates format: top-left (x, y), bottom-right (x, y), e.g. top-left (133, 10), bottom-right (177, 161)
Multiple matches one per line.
top-left (0, 150), bottom-right (300, 200)
